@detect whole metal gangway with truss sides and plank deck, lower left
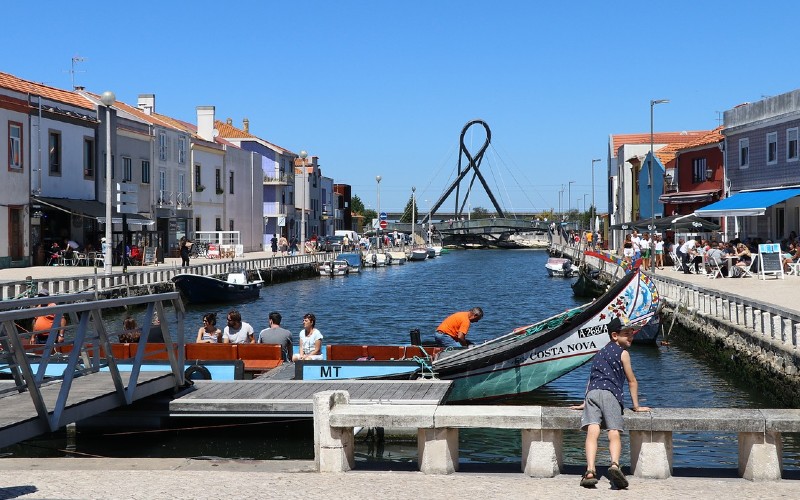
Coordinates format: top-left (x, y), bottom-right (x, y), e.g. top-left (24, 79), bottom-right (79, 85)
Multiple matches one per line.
top-left (0, 292), bottom-right (185, 448)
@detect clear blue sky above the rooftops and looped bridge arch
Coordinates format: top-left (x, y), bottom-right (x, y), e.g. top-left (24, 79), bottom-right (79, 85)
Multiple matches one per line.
top-left (0, 0), bottom-right (800, 215)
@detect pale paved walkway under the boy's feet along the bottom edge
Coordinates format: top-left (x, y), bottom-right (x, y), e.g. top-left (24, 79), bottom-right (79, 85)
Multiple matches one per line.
top-left (0, 458), bottom-right (800, 500)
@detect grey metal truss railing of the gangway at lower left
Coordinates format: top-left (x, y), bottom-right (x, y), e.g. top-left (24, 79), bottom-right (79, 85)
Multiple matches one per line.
top-left (0, 292), bottom-right (185, 431)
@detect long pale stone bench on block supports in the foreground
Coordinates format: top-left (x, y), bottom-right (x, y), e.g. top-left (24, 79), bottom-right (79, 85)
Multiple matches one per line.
top-left (314, 391), bottom-right (800, 480)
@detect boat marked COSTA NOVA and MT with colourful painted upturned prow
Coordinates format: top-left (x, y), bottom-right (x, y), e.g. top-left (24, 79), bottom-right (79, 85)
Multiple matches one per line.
top-left (295, 269), bottom-right (660, 402)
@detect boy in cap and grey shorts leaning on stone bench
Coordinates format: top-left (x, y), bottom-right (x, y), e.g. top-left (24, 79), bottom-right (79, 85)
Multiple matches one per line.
top-left (571, 318), bottom-right (650, 489)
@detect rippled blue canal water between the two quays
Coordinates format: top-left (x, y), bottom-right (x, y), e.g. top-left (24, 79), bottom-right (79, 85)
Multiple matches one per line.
top-left (0, 250), bottom-right (800, 471)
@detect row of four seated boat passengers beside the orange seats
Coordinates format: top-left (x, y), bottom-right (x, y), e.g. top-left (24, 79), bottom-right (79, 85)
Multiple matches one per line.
top-left (196, 309), bottom-right (323, 361)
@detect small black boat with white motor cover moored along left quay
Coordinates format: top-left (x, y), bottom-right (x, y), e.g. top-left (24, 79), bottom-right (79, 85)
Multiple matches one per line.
top-left (172, 267), bottom-right (264, 304)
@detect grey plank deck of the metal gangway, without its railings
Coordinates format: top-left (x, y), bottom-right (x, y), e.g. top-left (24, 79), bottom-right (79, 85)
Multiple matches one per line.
top-left (0, 371), bottom-right (175, 448)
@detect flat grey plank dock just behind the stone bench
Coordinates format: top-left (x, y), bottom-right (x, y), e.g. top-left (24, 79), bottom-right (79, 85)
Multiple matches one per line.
top-left (169, 379), bottom-right (450, 417)
